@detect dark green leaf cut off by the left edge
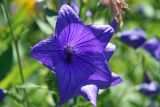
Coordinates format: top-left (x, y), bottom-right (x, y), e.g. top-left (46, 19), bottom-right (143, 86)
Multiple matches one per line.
top-left (0, 46), bottom-right (13, 80)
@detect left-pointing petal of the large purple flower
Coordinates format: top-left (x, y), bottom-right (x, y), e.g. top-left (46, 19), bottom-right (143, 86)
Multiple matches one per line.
top-left (31, 36), bottom-right (62, 70)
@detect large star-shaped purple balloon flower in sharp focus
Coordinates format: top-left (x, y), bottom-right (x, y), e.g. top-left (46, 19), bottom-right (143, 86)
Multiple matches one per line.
top-left (31, 5), bottom-right (122, 106)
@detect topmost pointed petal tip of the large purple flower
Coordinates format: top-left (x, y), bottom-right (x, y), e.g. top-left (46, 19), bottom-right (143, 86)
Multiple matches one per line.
top-left (56, 5), bottom-right (82, 35)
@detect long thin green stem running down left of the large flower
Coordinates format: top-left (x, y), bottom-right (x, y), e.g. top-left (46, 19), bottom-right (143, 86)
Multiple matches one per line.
top-left (2, 0), bottom-right (29, 107)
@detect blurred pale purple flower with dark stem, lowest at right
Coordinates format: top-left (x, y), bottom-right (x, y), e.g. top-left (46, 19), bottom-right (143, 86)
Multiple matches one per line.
top-left (139, 74), bottom-right (160, 98)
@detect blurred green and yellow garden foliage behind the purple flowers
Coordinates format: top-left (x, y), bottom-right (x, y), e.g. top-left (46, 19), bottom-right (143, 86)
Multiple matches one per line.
top-left (0, 0), bottom-right (160, 107)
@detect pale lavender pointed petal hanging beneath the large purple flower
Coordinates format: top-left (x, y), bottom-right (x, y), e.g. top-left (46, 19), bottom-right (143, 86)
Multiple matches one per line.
top-left (80, 84), bottom-right (99, 107)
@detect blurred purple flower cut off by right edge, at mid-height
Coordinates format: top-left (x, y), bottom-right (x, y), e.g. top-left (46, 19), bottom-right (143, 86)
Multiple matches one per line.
top-left (143, 37), bottom-right (160, 61)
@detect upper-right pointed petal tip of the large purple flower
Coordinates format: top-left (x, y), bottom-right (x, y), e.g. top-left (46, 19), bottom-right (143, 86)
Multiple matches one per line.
top-left (87, 20), bottom-right (117, 45)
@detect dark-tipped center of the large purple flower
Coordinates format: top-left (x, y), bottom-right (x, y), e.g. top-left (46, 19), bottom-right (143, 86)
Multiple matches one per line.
top-left (64, 46), bottom-right (75, 63)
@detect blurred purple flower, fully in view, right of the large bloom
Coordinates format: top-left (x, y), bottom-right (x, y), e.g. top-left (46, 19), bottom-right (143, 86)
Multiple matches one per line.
top-left (120, 28), bottom-right (146, 49)
